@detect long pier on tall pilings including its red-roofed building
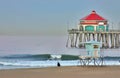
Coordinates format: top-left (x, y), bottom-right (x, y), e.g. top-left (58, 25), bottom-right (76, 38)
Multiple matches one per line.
top-left (66, 10), bottom-right (120, 48)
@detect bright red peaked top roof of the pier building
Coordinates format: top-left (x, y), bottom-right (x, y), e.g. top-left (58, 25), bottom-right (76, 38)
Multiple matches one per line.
top-left (81, 11), bottom-right (106, 20)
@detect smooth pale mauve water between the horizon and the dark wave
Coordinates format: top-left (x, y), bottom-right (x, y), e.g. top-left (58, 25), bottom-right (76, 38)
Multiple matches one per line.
top-left (0, 36), bottom-right (120, 56)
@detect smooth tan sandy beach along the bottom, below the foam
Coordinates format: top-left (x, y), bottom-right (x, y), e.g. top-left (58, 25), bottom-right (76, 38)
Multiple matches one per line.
top-left (0, 66), bottom-right (120, 78)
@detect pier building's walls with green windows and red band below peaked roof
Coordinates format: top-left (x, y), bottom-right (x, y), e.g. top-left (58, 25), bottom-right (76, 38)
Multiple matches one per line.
top-left (79, 20), bottom-right (108, 31)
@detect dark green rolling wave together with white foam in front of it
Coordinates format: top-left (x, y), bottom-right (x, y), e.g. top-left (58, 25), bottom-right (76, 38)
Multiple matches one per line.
top-left (0, 54), bottom-right (120, 69)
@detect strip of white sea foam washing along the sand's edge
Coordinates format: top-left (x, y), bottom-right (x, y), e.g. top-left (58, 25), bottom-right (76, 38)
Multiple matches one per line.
top-left (0, 60), bottom-right (120, 69)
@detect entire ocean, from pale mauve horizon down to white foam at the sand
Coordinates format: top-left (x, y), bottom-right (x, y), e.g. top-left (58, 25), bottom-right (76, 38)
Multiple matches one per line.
top-left (0, 36), bottom-right (120, 70)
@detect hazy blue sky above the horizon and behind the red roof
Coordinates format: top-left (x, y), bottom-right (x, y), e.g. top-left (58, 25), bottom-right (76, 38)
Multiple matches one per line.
top-left (0, 0), bottom-right (120, 35)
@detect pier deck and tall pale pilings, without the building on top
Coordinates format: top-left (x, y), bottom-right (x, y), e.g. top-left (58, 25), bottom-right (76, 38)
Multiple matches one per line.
top-left (66, 29), bottom-right (120, 48)
